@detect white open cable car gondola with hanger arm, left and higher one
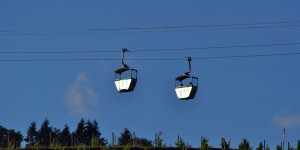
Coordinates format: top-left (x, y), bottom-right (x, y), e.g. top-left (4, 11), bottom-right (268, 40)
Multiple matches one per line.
top-left (115, 48), bottom-right (137, 93)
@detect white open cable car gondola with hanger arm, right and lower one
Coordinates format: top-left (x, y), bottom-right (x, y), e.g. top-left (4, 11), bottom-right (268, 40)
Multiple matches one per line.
top-left (175, 57), bottom-right (198, 100)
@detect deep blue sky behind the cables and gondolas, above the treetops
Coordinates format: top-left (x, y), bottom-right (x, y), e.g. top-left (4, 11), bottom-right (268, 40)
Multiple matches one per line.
top-left (0, 0), bottom-right (300, 149)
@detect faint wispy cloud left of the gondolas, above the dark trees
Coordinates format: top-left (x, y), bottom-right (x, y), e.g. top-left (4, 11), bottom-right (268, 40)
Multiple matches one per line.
top-left (65, 72), bottom-right (99, 116)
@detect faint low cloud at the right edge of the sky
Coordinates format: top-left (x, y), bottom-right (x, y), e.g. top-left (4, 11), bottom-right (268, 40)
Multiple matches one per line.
top-left (274, 113), bottom-right (300, 128)
